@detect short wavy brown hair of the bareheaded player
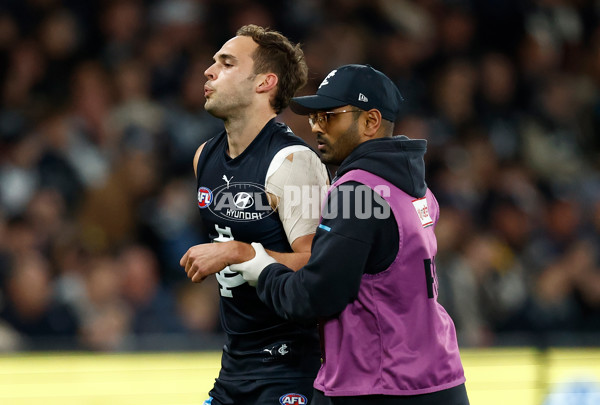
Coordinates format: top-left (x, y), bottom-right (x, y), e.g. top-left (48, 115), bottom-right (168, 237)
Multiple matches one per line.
top-left (236, 24), bottom-right (308, 114)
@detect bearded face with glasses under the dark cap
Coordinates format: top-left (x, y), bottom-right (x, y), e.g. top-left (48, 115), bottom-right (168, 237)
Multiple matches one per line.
top-left (310, 106), bottom-right (361, 165)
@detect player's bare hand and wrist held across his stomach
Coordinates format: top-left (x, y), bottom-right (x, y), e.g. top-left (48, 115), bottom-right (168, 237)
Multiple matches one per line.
top-left (179, 241), bottom-right (254, 283)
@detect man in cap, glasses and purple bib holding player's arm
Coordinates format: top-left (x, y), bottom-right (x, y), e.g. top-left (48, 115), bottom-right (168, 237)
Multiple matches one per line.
top-left (231, 65), bottom-right (469, 405)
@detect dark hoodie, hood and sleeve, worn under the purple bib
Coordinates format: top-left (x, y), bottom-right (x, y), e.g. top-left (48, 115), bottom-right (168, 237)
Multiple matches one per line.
top-left (256, 136), bottom-right (427, 321)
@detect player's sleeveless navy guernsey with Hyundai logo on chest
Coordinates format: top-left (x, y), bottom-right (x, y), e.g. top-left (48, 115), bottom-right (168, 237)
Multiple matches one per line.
top-left (197, 119), bottom-right (320, 380)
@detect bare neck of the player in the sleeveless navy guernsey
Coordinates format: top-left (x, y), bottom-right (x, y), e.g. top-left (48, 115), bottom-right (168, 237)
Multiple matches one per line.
top-left (225, 110), bottom-right (277, 158)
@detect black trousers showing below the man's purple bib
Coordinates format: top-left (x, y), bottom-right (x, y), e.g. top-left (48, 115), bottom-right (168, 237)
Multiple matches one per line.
top-left (310, 384), bottom-right (469, 405)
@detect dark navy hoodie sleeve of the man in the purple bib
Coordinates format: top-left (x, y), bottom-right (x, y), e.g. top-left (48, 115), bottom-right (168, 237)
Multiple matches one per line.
top-left (256, 182), bottom-right (399, 321)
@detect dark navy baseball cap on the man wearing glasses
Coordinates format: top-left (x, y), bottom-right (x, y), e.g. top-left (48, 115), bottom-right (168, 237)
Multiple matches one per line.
top-left (290, 65), bottom-right (404, 122)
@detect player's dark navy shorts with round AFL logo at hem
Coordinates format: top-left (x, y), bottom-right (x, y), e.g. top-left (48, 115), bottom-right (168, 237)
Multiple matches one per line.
top-left (206, 377), bottom-right (315, 405)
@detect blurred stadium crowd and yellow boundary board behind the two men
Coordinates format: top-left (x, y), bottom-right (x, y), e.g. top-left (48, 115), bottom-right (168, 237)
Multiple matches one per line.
top-left (0, 0), bottom-right (600, 405)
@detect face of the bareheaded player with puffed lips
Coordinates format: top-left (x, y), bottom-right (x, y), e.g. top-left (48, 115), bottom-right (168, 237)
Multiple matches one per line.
top-left (204, 36), bottom-right (258, 119)
